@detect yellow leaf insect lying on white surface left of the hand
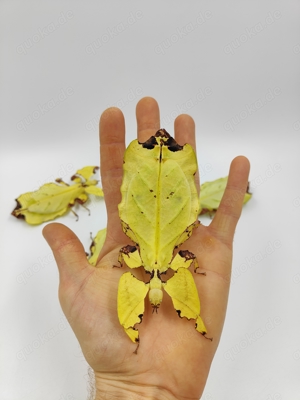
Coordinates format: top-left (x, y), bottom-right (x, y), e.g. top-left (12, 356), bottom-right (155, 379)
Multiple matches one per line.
top-left (12, 166), bottom-right (103, 225)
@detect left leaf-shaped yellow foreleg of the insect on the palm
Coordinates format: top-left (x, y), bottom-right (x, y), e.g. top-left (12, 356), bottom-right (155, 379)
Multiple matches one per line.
top-left (118, 272), bottom-right (149, 343)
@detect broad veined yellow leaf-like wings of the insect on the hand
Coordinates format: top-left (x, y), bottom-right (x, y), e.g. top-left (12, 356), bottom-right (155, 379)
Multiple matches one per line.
top-left (119, 134), bottom-right (199, 272)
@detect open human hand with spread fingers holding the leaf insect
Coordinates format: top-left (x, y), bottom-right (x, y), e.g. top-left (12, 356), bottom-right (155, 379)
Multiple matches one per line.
top-left (43, 97), bottom-right (249, 400)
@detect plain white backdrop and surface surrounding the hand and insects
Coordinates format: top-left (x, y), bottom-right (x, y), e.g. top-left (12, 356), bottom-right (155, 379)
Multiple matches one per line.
top-left (0, 0), bottom-right (300, 400)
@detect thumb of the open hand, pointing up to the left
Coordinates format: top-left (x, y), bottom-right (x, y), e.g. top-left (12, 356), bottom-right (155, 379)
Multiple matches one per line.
top-left (43, 223), bottom-right (90, 284)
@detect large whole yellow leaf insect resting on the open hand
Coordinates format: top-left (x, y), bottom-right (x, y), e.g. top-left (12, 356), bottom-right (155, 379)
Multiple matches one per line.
top-left (118, 129), bottom-right (212, 343)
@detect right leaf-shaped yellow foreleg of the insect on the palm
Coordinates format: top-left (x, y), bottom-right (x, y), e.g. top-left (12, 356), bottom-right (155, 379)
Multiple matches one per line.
top-left (163, 268), bottom-right (207, 335)
